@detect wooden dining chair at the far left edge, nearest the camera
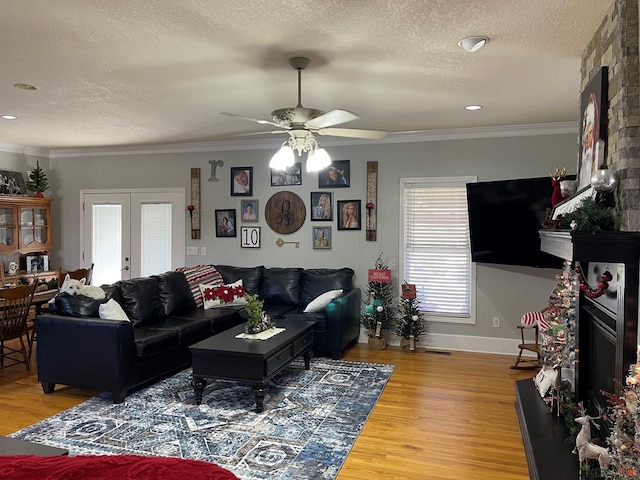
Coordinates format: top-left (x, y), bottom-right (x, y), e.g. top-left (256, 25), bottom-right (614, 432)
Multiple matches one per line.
top-left (0, 284), bottom-right (36, 371)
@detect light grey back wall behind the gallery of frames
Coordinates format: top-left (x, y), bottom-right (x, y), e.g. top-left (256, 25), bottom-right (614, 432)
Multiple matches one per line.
top-left (0, 129), bottom-right (577, 353)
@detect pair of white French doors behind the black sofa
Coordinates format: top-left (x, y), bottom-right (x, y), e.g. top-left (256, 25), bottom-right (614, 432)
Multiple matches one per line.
top-left (80, 189), bottom-right (185, 285)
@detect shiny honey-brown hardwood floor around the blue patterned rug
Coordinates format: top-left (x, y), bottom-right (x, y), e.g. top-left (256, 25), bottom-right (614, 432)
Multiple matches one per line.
top-left (0, 344), bottom-right (535, 480)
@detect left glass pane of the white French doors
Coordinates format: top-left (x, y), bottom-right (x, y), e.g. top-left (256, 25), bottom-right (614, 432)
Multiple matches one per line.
top-left (91, 205), bottom-right (122, 285)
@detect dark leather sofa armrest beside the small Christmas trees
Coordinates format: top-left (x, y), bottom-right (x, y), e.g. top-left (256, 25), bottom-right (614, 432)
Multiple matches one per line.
top-left (325, 287), bottom-right (362, 358)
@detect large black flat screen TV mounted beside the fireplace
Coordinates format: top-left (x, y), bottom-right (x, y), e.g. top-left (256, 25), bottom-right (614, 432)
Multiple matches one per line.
top-left (467, 176), bottom-right (575, 268)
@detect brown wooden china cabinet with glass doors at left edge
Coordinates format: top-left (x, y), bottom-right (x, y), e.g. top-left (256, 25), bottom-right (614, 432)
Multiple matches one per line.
top-left (0, 196), bottom-right (55, 281)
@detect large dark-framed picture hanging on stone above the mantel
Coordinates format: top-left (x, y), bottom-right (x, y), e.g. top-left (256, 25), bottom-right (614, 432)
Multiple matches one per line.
top-left (577, 67), bottom-right (609, 191)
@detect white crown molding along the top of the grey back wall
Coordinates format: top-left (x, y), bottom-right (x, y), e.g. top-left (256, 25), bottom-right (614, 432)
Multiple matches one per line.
top-left (0, 122), bottom-right (579, 158)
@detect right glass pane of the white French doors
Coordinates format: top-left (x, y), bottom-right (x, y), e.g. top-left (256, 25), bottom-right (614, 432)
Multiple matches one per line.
top-left (140, 203), bottom-right (171, 277)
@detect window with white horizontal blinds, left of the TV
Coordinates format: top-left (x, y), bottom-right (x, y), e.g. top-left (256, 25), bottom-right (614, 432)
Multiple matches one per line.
top-left (400, 177), bottom-right (476, 324)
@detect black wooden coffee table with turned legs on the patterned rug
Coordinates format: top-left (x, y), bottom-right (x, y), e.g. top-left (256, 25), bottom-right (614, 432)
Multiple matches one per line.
top-left (189, 319), bottom-right (314, 412)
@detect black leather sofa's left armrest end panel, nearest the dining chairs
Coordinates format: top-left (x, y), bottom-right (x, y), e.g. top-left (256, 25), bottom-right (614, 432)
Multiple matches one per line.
top-left (36, 314), bottom-right (135, 392)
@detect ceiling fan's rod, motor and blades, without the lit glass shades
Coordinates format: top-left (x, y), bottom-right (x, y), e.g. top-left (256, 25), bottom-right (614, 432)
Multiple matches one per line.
top-left (220, 57), bottom-right (387, 139)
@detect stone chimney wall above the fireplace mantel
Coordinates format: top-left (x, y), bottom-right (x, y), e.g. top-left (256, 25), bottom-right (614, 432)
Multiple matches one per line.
top-left (580, 0), bottom-right (640, 232)
